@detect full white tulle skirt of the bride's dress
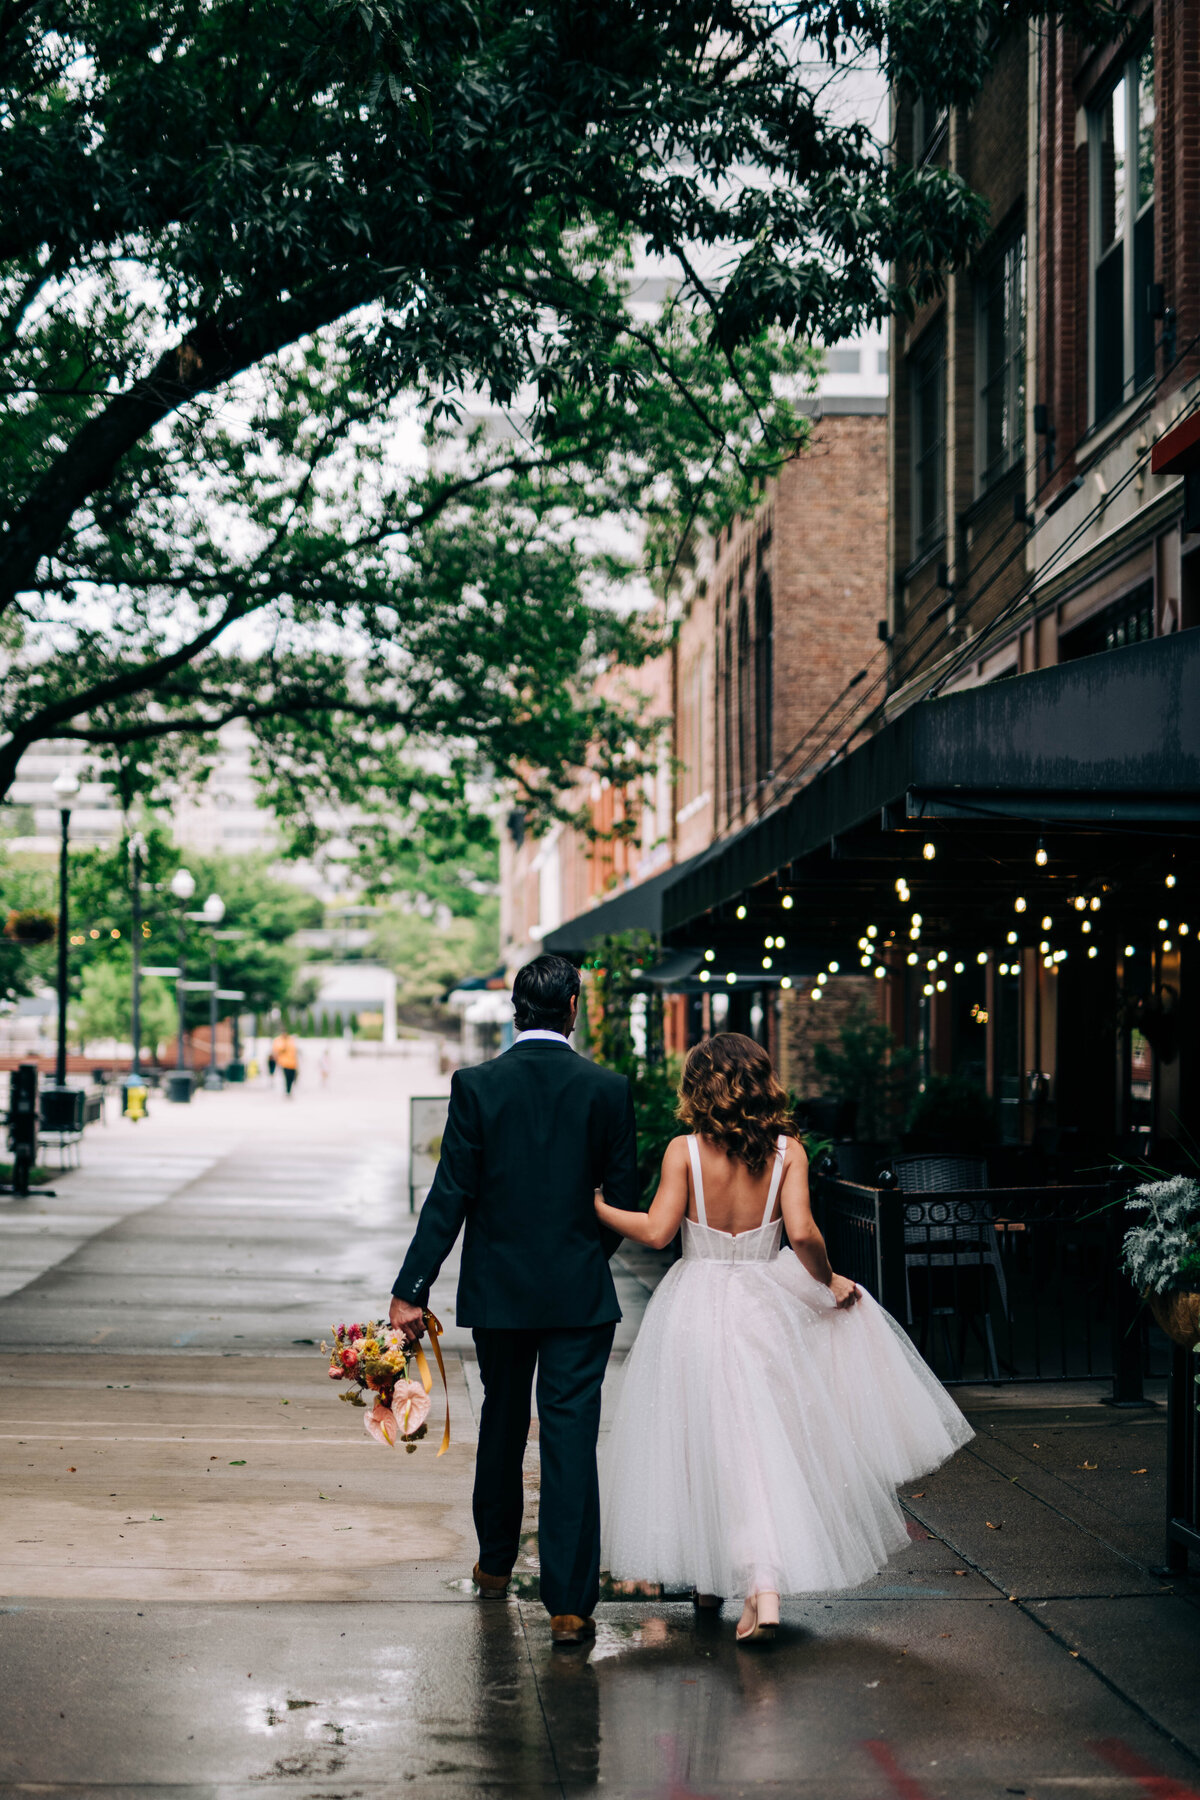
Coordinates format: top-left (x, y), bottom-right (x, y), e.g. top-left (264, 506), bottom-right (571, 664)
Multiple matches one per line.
top-left (601, 1249), bottom-right (973, 1597)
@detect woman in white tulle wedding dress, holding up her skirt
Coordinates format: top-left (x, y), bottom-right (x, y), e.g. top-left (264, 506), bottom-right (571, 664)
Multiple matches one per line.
top-left (596, 1031), bottom-right (973, 1642)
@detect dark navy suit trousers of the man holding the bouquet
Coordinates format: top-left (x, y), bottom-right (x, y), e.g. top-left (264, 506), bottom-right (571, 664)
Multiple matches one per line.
top-left (473, 1325), bottom-right (615, 1618)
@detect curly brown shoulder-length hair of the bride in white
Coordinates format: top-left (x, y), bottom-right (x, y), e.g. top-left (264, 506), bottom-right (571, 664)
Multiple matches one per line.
top-left (676, 1031), bottom-right (799, 1175)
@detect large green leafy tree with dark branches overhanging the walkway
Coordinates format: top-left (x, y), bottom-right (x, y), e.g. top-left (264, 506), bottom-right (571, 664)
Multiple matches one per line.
top-left (0, 0), bottom-right (1110, 849)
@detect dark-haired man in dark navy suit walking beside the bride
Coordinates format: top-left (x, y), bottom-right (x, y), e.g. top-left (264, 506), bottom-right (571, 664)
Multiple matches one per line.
top-left (390, 956), bottom-right (639, 1643)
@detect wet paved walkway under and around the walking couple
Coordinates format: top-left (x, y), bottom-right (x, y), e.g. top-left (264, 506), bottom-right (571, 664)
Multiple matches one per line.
top-left (0, 1067), bottom-right (1200, 1800)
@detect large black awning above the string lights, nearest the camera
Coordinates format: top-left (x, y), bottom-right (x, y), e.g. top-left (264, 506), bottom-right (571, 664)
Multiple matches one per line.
top-left (658, 630), bottom-right (1200, 932)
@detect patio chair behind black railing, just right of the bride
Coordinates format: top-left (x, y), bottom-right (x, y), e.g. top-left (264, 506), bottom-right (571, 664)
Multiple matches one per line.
top-left (892, 1156), bottom-right (1007, 1381)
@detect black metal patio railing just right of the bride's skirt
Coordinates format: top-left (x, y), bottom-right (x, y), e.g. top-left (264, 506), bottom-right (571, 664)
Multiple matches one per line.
top-left (813, 1175), bottom-right (1150, 1404)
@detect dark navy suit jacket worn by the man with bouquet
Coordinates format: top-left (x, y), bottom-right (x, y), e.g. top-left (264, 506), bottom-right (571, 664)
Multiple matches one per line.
top-left (392, 1039), bottom-right (639, 1330)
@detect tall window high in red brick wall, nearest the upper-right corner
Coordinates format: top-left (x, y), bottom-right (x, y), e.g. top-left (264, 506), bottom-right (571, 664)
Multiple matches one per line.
top-left (1088, 45), bottom-right (1155, 425)
